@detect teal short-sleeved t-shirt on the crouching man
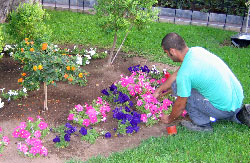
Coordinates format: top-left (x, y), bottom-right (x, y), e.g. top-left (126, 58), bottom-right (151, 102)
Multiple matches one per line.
top-left (176, 47), bottom-right (244, 111)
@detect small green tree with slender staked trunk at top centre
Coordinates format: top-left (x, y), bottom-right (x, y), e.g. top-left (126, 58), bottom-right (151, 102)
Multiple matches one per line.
top-left (95, 0), bottom-right (158, 65)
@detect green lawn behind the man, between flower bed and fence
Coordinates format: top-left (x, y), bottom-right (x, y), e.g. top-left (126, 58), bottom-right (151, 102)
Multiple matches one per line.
top-left (42, 10), bottom-right (250, 103)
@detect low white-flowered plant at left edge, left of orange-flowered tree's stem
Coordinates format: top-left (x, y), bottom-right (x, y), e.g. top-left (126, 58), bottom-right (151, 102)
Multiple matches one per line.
top-left (1, 87), bottom-right (28, 101)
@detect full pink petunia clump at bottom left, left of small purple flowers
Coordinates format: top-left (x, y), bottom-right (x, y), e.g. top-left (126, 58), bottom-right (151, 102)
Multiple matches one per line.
top-left (12, 116), bottom-right (49, 157)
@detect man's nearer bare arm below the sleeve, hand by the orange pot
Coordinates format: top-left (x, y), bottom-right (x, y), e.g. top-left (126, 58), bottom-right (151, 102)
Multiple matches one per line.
top-left (161, 96), bottom-right (187, 123)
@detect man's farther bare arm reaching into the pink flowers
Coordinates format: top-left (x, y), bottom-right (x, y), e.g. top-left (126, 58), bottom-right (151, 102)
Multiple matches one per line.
top-left (153, 68), bottom-right (179, 98)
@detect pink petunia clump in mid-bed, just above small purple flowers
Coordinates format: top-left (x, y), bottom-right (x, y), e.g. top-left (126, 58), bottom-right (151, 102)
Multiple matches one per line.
top-left (68, 97), bottom-right (110, 127)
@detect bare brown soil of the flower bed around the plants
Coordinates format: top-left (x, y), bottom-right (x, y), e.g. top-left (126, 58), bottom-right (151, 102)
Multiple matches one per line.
top-left (0, 50), bottom-right (180, 163)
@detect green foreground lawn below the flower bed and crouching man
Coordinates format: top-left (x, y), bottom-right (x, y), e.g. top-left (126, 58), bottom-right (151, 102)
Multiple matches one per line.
top-left (87, 121), bottom-right (250, 163)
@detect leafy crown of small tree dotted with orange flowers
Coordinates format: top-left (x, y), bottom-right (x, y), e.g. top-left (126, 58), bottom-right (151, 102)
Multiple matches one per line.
top-left (13, 38), bottom-right (87, 90)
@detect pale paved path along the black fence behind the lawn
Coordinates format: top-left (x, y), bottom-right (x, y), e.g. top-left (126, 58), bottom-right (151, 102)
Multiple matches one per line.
top-left (43, 3), bottom-right (244, 32)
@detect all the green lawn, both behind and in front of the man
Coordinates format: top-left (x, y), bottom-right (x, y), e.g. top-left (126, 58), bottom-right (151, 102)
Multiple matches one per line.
top-left (2, 11), bottom-right (250, 162)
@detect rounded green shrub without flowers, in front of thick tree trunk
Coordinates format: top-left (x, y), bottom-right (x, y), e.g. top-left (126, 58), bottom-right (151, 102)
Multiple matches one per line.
top-left (7, 3), bottom-right (51, 41)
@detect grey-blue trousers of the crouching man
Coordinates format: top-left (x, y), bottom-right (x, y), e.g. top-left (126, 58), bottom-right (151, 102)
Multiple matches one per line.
top-left (172, 82), bottom-right (240, 126)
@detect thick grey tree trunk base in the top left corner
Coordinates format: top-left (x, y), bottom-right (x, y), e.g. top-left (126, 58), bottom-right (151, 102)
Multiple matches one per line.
top-left (0, 0), bottom-right (41, 23)
